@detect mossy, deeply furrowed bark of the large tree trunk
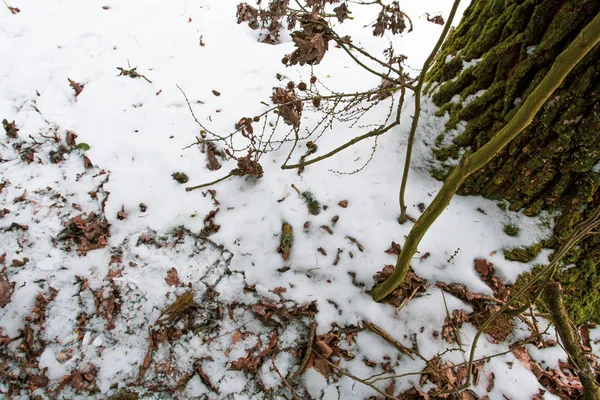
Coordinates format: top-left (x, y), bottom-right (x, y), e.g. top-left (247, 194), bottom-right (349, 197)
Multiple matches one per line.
top-left (426, 0), bottom-right (600, 324)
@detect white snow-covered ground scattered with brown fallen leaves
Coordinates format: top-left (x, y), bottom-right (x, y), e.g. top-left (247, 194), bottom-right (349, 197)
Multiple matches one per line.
top-left (0, 0), bottom-right (600, 399)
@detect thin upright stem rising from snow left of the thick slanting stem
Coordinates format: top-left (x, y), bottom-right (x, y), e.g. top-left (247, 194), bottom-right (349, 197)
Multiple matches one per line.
top-left (398, 0), bottom-right (460, 224)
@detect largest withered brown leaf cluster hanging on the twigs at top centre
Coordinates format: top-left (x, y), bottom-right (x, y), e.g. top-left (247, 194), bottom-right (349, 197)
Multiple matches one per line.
top-left (281, 14), bottom-right (333, 65)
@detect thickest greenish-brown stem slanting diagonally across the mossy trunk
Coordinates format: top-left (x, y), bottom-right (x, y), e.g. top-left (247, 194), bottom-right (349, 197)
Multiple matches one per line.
top-left (372, 10), bottom-right (600, 301)
